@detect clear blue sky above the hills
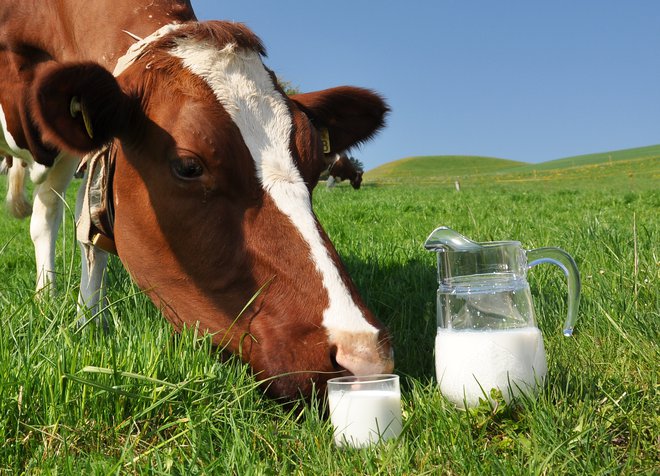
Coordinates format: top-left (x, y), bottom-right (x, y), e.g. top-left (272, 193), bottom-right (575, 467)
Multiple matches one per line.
top-left (192, 0), bottom-right (660, 170)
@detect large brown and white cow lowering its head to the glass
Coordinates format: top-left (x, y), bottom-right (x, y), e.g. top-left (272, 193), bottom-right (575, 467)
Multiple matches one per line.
top-left (0, 0), bottom-right (393, 398)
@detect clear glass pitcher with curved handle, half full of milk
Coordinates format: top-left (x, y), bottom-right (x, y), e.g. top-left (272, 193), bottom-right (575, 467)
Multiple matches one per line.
top-left (424, 227), bottom-right (580, 407)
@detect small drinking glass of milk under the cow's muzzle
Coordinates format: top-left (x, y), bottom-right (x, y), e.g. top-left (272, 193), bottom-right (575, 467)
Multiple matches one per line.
top-left (328, 374), bottom-right (401, 448)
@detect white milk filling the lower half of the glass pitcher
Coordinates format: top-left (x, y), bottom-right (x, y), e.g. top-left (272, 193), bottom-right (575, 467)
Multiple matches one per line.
top-left (435, 327), bottom-right (548, 407)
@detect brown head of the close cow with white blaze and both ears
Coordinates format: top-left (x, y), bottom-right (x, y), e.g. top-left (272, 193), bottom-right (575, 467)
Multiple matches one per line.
top-left (33, 22), bottom-right (393, 398)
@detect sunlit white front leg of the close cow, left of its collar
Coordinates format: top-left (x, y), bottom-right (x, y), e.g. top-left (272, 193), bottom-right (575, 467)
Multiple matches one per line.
top-left (30, 156), bottom-right (78, 293)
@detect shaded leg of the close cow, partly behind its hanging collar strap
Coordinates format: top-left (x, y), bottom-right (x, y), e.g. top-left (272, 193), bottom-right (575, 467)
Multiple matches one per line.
top-left (76, 174), bottom-right (108, 324)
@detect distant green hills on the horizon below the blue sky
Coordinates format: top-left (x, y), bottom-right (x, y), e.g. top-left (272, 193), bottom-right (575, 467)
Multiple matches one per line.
top-left (364, 145), bottom-right (660, 188)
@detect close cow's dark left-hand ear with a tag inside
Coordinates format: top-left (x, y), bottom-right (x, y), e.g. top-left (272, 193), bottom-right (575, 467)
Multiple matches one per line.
top-left (32, 63), bottom-right (132, 154)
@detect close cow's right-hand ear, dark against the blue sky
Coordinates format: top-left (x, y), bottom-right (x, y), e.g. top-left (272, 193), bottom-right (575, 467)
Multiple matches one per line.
top-left (291, 86), bottom-right (389, 153)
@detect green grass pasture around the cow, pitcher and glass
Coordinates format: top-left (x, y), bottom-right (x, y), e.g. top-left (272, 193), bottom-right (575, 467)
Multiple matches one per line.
top-left (0, 162), bottom-right (660, 475)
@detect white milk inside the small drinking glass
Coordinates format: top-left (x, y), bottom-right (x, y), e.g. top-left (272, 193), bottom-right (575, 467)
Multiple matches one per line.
top-left (328, 390), bottom-right (401, 448)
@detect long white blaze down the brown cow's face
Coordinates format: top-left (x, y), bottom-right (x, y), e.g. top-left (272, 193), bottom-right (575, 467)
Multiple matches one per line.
top-left (171, 39), bottom-right (378, 334)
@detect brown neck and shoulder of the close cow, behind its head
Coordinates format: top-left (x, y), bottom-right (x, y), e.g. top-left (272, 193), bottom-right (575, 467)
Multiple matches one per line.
top-left (0, 0), bottom-right (195, 166)
